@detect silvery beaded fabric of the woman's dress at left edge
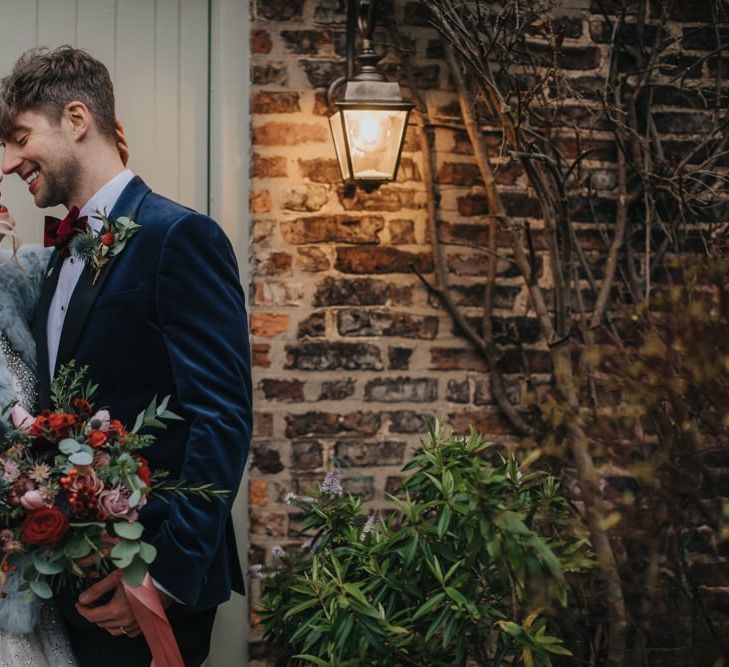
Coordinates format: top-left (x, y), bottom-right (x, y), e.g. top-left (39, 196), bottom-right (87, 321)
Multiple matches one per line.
top-left (0, 333), bottom-right (76, 667)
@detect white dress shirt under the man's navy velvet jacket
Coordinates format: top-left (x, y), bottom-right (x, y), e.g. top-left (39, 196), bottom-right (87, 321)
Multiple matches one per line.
top-left (46, 169), bottom-right (134, 380)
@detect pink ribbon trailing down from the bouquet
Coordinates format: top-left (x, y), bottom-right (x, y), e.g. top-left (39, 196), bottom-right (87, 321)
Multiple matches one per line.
top-left (124, 574), bottom-right (185, 667)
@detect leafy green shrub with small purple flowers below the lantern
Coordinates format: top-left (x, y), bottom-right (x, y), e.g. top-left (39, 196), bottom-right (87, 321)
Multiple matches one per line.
top-left (261, 422), bottom-right (591, 666)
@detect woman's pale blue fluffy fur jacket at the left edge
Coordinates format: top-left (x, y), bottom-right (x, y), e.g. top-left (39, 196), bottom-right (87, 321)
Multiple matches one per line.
top-left (0, 245), bottom-right (50, 633)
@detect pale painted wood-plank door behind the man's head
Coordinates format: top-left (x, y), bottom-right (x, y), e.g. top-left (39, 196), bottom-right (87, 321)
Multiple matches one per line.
top-left (0, 0), bottom-right (209, 242)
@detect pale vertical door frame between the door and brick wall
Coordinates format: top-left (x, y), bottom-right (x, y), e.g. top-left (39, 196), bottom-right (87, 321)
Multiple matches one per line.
top-left (208, 0), bottom-right (250, 667)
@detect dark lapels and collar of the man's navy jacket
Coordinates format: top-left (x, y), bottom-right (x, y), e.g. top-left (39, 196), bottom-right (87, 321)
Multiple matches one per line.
top-left (52, 176), bottom-right (150, 373)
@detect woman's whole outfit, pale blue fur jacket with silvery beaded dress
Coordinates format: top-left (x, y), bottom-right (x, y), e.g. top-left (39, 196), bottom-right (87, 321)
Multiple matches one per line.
top-left (0, 246), bottom-right (76, 667)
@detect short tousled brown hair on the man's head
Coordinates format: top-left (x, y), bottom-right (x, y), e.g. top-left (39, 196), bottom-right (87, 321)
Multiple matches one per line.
top-left (0, 46), bottom-right (116, 141)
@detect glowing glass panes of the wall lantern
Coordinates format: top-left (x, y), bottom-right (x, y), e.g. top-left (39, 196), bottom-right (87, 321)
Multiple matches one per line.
top-left (335, 109), bottom-right (408, 180)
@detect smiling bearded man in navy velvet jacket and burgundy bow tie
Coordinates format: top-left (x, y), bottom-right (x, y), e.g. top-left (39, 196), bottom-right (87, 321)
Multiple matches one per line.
top-left (0, 46), bottom-right (251, 667)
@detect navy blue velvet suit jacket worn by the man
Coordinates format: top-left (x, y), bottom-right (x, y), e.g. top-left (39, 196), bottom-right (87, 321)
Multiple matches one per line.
top-left (35, 177), bottom-right (252, 621)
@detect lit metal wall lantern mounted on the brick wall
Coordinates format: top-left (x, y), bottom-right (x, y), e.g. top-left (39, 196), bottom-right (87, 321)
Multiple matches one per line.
top-left (327, 0), bottom-right (415, 186)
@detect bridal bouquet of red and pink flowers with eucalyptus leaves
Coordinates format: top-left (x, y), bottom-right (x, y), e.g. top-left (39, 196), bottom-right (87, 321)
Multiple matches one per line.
top-left (0, 363), bottom-right (220, 598)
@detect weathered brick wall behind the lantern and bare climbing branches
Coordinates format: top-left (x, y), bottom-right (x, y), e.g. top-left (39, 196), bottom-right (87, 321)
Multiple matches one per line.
top-left (249, 0), bottom-right (729, 665)
